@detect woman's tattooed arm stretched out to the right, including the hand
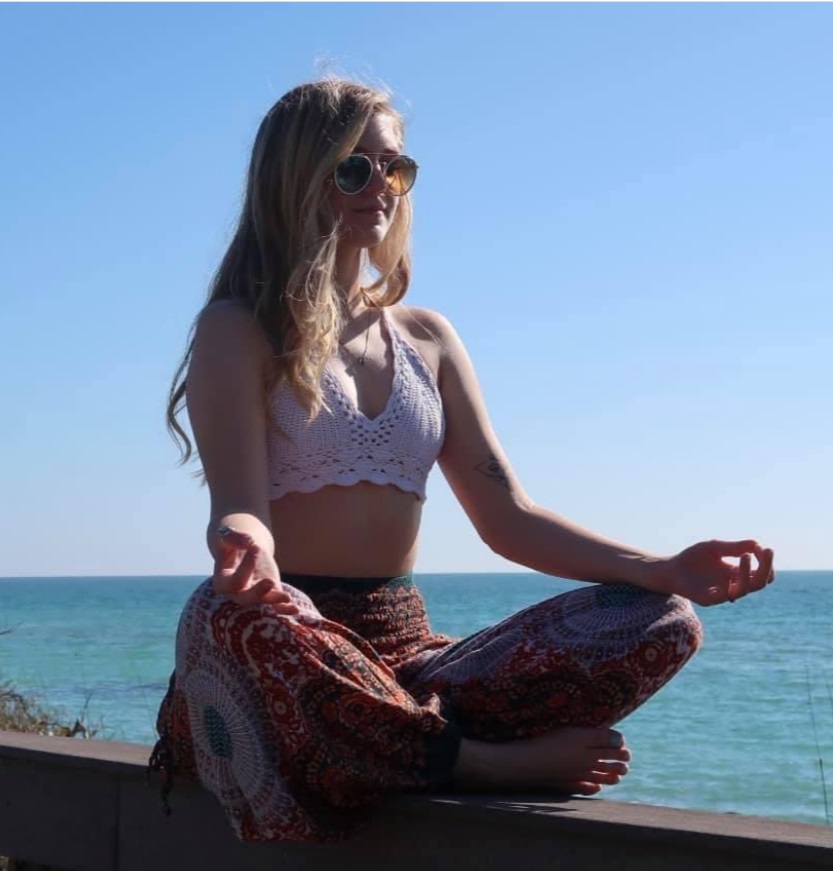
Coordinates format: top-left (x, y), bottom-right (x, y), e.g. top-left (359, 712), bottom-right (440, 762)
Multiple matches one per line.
top-left (422, 312), bottom-right (772, 604)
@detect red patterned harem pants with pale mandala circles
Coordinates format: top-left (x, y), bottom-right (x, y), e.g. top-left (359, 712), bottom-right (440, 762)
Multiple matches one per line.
top-left (151, 575), bottom-right (702, 841)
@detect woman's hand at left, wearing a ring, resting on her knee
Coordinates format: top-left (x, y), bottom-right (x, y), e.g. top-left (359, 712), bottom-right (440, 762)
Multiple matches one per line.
top-left (213, 526), bottom-right (298, 616)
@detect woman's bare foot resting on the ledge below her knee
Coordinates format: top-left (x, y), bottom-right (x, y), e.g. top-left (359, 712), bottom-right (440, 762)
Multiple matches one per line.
top-left (454, 726), bottom-right (631, 795)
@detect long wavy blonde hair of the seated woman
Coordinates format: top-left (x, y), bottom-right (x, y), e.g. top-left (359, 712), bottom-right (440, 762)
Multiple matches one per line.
top-left (167, 78), bottom-right (411, 462)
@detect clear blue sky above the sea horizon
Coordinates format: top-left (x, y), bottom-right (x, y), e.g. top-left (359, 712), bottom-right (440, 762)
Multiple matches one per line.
top-left (0, 3), bottom-right (833, 575)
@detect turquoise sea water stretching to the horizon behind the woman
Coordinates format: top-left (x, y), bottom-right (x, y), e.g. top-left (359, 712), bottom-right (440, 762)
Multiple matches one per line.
top-left (0, 572), bottom-right (833, 824)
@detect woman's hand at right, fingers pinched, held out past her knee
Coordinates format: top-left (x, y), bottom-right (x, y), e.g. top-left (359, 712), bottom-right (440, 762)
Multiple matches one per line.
top-left (663, 539), bottom-right (775, 605)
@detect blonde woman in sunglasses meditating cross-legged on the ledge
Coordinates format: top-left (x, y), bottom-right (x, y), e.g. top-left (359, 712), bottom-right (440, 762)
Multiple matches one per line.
top-left (152, 80), bottom-right (773, 841)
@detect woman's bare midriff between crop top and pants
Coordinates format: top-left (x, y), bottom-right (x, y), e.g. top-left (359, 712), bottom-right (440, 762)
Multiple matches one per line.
top-left (270, 482), bottom-right (422, 578)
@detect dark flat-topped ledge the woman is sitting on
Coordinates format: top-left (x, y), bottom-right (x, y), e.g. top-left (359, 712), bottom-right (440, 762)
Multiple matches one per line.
top-left (0, 732), bottom-right (833, 871)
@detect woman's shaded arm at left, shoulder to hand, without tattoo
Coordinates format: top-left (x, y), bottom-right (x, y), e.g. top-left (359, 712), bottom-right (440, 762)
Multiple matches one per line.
top-left (186, 302), bottom-right (294, 613)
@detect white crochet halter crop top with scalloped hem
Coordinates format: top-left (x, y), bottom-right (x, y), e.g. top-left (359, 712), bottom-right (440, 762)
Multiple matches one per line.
top-left (267, 308), bottom-right (445, 501)
